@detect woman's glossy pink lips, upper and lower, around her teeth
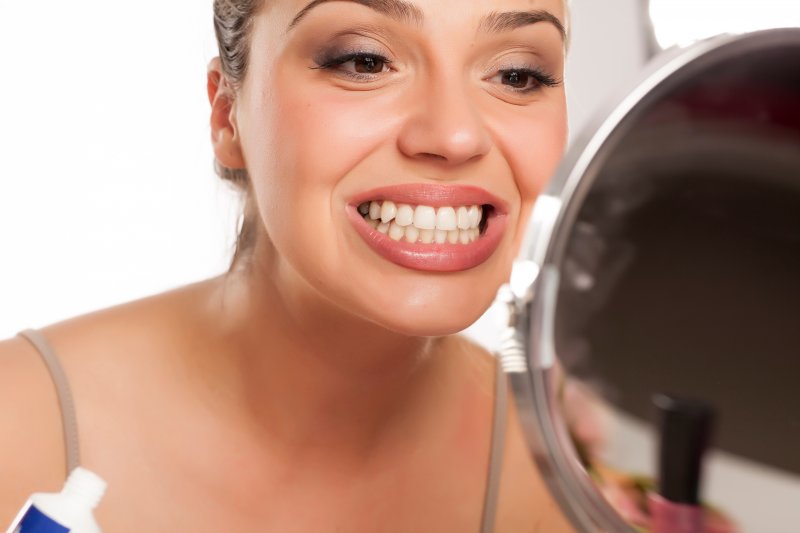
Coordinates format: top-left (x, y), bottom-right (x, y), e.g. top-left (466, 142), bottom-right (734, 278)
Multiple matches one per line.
top-left (347, 185), bottom-right (508, 272)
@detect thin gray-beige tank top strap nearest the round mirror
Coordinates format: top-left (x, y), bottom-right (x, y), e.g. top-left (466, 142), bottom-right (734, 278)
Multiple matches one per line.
top-left (481, 356), bottom-right (508, 533)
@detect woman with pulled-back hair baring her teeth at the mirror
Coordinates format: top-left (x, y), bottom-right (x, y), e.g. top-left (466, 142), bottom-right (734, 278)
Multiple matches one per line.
top-left (0, 0), bottom-right (569, 532)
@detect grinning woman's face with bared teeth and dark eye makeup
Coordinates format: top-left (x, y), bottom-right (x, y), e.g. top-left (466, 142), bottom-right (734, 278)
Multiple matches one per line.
top-left (234, 0), bottom-right (567, 335)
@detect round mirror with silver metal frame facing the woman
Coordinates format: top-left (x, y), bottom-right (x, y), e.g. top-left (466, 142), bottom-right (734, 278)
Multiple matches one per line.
top-left (501, 29), bottom-right (800, 532)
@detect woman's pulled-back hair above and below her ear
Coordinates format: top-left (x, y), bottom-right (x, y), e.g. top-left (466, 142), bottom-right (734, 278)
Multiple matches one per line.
top-left (214, 0), bottom-right (264, 270)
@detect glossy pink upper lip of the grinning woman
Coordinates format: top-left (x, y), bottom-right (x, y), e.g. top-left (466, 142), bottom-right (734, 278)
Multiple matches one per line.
top-left (350, 183), bottom-right (508, 214)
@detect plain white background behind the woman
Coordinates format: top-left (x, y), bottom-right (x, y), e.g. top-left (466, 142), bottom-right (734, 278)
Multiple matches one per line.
top-left (0, 0), bottom-right (644, 338)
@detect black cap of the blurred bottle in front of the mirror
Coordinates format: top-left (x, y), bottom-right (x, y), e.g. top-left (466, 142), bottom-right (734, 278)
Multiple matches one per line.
top-left (653, 394), bottom-right (715, 505)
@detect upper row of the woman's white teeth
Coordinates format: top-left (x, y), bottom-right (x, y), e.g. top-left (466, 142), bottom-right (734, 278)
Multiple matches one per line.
top-left (359, 200), bottom-right (483, 231)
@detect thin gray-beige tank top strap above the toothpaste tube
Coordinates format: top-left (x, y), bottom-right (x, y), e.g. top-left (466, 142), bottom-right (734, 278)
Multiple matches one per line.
top-left (19, 329), bottom-right (80, 475)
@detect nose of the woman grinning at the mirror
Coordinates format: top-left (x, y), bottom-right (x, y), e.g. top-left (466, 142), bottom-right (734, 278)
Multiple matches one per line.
top-left (398, 71), bottom-right (491, 166)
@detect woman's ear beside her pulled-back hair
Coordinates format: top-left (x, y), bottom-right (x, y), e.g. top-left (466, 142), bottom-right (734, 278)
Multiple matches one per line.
top-left (207, 57), bottom-right (245, 169)
